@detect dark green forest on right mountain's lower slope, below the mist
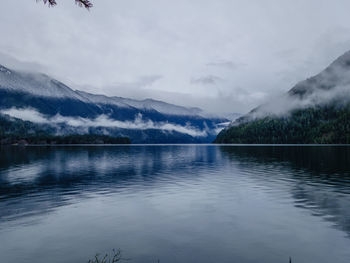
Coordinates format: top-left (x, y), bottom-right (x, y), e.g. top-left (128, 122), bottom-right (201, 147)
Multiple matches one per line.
top-left (214, 104), bottom-right (350, 144)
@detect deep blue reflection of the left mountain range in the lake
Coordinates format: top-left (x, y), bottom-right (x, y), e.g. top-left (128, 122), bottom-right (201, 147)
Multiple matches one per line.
top-left (0, 146), bottom-right (222, 225)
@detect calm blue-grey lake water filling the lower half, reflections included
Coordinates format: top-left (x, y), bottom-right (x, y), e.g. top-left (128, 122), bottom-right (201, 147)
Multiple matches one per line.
top-left (0, 145), bottom-right (350, 263)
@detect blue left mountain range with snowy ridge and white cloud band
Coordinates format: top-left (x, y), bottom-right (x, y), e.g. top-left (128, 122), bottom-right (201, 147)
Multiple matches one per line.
top-left (0, 65), bottom-right (228, 143)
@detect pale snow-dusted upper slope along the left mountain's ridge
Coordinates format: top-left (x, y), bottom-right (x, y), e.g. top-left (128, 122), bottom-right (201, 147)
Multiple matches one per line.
top-left (0, 65), bottom-right (224, 118)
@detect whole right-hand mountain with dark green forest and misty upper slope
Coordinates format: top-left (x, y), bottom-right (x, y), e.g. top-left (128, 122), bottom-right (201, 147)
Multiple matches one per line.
top-left (214, 51), bottom-right (350, 144)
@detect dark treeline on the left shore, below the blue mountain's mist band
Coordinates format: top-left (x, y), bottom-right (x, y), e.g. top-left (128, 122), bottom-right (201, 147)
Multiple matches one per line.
top-left (0, 115), bottom-right (131, 145)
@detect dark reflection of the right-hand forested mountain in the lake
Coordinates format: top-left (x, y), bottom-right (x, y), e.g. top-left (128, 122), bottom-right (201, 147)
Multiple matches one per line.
top-left (220, 146), bottom-right (350, 238)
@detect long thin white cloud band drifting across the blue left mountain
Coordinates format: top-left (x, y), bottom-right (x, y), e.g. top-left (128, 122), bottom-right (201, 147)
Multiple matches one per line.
top-left (0, 108), bottom-right (210, 137)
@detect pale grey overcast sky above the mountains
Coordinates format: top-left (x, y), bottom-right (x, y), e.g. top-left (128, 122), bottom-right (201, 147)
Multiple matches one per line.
top-left (0, 0), bottom-right (350, 113)
